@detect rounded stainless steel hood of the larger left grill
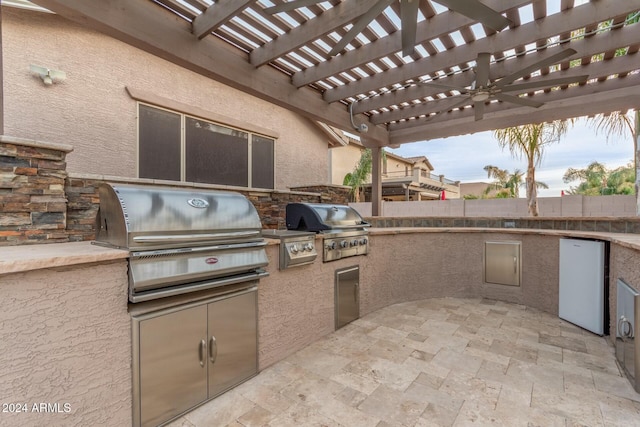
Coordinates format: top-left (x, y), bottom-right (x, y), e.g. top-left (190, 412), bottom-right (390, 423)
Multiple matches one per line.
top-left (96, 184), bottom-right (262, 250)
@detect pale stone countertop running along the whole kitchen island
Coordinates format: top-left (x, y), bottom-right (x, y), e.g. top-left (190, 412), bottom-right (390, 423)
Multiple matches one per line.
top-left (0, 227), bottom-right (640, 277)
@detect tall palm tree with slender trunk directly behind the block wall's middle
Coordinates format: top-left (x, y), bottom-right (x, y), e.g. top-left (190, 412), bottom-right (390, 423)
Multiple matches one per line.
top-left (494, 120), bottom-right (569, 216)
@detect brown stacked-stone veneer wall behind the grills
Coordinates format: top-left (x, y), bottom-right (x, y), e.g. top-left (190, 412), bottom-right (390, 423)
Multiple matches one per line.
top-left (0, 135), bottom-right (356, 246)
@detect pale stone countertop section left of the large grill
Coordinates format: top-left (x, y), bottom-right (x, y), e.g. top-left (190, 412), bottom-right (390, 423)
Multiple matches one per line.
top-left (0, 242), bottom-right (129, 277)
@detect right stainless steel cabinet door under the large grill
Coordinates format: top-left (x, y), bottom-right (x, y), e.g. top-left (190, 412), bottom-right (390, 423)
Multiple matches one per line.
top-left (208, 291), bottom-right (258, 398)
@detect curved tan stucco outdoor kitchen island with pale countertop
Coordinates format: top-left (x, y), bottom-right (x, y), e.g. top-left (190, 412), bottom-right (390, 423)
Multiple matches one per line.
top-left (0, 228), bottom-right (640, 426)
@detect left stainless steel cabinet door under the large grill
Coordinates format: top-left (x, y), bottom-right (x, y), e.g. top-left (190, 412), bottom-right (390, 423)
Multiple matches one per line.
top-left (134, 305), bottom-right (207, 426)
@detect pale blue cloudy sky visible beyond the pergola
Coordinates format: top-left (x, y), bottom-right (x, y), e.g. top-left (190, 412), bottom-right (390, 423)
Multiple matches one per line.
top-left (388, 118), bottom-right (633, 197)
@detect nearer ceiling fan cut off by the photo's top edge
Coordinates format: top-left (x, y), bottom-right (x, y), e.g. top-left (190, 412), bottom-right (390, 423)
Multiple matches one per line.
top-left (264, 0), bottom-right (511, 56)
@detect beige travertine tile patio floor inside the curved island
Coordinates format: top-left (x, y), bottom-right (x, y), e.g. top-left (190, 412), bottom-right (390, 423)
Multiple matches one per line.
top-left (171, 298), bottom-right (640, 427)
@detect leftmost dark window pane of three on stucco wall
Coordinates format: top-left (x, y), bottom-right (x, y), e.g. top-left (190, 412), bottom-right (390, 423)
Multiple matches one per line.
top-left (138, 105), bottom-right (180, 181)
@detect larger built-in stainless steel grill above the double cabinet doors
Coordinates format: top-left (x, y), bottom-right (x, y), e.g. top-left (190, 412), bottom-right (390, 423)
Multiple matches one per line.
top-left (95, 184), bottom-right (268, 302)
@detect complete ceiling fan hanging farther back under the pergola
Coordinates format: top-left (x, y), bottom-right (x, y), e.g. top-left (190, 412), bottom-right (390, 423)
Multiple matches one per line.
top-left (421, 49), bottom-right (589, 121)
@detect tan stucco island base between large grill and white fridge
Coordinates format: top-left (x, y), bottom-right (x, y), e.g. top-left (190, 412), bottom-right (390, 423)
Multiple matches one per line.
top-left (258, 231), bottom-right (559, 369)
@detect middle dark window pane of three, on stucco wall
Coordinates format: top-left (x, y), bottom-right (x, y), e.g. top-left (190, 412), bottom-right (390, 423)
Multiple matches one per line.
top-left (185, 117), bottom-right (249, 187)
